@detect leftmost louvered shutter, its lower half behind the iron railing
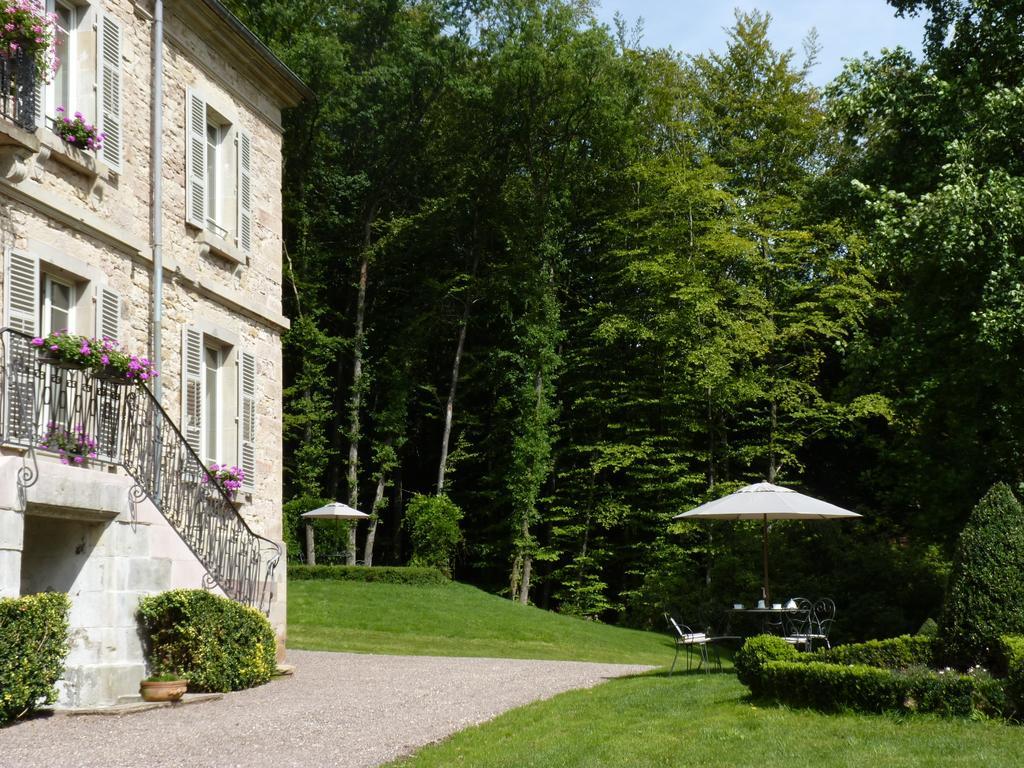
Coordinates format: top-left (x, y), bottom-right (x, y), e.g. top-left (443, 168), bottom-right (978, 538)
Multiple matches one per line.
top-left (3, 251), bottom-right (39, 443)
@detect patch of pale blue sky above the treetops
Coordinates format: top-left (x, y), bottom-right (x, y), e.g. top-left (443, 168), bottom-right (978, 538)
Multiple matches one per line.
top-left (598, 0), bottom-right (924, 85)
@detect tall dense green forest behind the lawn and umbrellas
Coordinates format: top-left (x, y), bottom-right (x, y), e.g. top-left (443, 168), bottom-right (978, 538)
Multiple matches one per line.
top-left (228, 0), bottom-right (1024, 635)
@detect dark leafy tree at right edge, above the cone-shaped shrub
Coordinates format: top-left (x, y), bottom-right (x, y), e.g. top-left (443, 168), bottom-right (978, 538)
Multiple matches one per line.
top-left (829, 0), bottom-right (1024, 539)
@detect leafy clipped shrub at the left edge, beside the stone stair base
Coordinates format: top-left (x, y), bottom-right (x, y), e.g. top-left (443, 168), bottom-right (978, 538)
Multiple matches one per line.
top-left (0, 592), bottom-right (71, 725)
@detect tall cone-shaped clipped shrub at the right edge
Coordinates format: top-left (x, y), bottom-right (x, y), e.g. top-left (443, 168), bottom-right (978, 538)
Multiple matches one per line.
top-left (939, 482), bottom-right (1024, 670)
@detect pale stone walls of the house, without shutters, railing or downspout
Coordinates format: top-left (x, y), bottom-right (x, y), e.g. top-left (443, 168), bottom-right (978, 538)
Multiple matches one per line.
top-left (0, 0), bottom-right (304, 706)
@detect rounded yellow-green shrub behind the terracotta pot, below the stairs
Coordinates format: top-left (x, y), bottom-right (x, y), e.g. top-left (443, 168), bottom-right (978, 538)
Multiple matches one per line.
top-left (138, 590), bottom-right (276, 691)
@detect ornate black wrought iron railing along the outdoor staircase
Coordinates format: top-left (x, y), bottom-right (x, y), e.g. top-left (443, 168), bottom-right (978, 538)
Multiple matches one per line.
top-left (0, 328), bottom-right (282, 612)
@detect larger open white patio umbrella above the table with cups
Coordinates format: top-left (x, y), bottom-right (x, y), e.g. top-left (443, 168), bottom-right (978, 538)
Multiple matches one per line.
top-left (672, 482), bottom-right (860, 602)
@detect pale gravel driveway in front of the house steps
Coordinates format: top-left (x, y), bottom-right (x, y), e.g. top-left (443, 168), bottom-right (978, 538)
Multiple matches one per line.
top-left (0, 650), bottom-right (650, 768)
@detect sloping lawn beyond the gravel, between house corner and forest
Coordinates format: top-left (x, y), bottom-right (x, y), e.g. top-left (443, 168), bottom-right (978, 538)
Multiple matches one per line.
top-left (288, 581), bottom-right (674, 666)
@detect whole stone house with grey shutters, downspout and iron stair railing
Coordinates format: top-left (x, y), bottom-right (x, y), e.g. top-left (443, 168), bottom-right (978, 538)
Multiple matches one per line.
top-left (0, 0), bottom-right (308, 706)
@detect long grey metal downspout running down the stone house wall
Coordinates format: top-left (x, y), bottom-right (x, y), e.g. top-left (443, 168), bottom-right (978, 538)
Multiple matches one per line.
top-left (150, 0), bottom-right (164, 404)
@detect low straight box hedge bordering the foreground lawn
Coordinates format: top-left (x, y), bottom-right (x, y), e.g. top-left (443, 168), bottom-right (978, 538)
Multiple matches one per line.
top-left (759, 662), bottom-right (976, 716)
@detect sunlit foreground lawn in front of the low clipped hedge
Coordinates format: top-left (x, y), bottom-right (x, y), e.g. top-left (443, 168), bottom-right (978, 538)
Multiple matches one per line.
top-left (392, 674), bottom-right (1024, 768)
